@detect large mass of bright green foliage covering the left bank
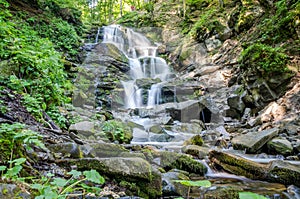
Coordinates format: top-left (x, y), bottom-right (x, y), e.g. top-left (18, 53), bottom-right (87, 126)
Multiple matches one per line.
top-left (0, 7), bottom-right (72, 124)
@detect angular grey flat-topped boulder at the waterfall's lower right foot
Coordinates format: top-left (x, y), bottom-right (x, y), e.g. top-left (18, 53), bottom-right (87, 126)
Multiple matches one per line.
top-left (166, 100), bottom-right (205, 122)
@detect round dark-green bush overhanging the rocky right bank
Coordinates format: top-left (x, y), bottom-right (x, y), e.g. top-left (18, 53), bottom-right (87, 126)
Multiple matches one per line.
top-left (239, 43), bottom-right (288, 76)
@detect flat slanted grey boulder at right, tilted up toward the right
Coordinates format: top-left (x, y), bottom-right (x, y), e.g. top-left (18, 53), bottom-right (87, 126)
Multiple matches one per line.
top-left (231, 128), bottom-right (279, 153)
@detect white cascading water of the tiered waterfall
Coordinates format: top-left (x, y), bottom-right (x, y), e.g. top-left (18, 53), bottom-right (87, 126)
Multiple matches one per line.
top-left (103, 25), bottom-right (171, 108)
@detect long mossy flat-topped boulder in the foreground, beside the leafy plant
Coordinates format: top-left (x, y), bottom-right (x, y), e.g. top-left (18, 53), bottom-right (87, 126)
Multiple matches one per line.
top-left (56, 157), bottom-right (162, 198)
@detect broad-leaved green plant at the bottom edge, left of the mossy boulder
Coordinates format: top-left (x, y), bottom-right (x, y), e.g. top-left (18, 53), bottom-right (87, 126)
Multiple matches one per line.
top-left (31, 170), bottom-right (105, 199)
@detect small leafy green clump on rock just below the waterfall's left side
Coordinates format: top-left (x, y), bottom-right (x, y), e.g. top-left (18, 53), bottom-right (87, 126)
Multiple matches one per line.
top-left (102, 120), bottom-right (132, 143)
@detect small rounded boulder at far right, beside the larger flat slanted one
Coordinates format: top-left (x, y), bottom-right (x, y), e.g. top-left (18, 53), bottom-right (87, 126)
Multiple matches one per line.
top-left (267, 137), bottom-right (293, 155)
